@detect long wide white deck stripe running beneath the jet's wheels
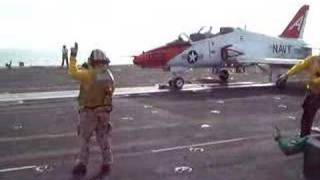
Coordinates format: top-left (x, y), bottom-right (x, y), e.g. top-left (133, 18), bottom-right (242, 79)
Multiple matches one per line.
top-left (0, 82), bottom-right (274, 103)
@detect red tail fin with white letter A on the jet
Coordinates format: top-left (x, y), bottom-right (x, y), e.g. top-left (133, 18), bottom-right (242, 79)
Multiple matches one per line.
top-left (280, 5), bottom-right (309, 38)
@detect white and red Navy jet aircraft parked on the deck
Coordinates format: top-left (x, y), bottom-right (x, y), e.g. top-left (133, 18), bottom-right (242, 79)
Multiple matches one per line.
top-left (133, 5), bottom-right (312, 89)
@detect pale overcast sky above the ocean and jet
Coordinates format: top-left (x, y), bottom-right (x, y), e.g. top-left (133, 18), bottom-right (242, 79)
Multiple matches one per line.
top-left (0, 0), bottom-right (320, 62)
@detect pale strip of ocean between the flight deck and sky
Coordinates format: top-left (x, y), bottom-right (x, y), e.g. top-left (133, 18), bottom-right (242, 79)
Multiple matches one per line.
top-left (0, 49), bottom-right (132, 67)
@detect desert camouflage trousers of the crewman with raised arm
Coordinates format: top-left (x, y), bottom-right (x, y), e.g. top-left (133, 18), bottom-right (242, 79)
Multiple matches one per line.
top-left (77, 107), bottom-right (112, 165)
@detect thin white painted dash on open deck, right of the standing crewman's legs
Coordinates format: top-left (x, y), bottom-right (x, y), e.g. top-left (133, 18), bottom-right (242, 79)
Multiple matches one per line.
top-left (151, 137), bottom-right (252, 153)
